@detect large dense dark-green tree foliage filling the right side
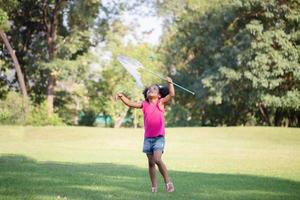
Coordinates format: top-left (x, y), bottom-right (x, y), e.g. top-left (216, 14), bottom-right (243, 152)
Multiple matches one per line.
top-left (161, 0), bottom-right (300, 126)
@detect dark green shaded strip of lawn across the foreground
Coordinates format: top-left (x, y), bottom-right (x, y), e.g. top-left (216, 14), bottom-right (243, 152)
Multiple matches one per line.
top-left (0, 155), bottom-right (300, 200)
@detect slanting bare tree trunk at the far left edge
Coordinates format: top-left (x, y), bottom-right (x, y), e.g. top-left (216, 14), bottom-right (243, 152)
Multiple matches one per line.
top-left (0, 29), bottom-right (28, 112)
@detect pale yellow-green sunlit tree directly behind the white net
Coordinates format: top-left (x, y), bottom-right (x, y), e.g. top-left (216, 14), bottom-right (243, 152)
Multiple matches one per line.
top-left (85, 21), bottom-right (165, 127)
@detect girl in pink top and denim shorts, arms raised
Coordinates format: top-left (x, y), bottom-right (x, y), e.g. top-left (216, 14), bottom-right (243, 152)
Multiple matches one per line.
top-left (117, 77), bottom-right (175, 192)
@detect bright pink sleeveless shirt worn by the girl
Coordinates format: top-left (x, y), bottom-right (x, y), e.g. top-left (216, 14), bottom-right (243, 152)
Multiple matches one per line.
top-left (142, 100), bottom-right (165, 138)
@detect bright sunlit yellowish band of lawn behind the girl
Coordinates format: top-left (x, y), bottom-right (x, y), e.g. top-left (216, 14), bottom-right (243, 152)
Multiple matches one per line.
top-left (0, 126), bottom-right (300, 180)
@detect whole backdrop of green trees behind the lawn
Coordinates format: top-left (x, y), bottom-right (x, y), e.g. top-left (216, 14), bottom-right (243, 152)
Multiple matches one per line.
top-left (0, 0), bottom-right (300, 127)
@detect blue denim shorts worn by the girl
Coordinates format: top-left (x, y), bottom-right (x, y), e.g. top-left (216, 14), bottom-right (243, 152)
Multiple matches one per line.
top-left (143, 136), bottom-right (165, 154)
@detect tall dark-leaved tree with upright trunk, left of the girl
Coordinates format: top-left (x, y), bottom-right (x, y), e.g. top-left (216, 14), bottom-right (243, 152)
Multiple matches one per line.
top-left (0, 0), bottom-right (99, 115)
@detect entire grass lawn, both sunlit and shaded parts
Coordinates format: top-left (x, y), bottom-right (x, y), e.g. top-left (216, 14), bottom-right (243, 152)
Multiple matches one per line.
top-left (0, 126), bottom-right (300, 200)
